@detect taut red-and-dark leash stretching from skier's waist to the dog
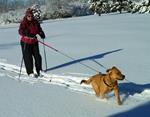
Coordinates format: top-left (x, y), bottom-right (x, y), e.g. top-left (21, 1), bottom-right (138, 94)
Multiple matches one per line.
top-left (38, 40), bottom-right (99, 72)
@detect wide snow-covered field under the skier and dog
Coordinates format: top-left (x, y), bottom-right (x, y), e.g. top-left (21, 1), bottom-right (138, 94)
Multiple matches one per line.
top-left (0, 14), bottom-right (150, 117)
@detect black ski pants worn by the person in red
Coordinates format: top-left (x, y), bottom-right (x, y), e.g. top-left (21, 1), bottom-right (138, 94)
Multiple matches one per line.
top-left (20, 41), bottom-right (42, 75)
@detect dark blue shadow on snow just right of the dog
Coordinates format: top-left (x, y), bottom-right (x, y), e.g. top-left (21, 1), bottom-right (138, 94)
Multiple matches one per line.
top-left (119, 82), bottom-right (150, 102)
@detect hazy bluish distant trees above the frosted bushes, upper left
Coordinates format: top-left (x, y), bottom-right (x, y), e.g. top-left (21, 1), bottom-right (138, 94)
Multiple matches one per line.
top-left (0, 0), bottom-right (88, 13)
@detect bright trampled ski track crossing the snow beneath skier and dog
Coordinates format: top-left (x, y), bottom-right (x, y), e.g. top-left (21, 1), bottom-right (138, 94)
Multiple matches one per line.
top-left (0, 61), bottom-right (150, 105)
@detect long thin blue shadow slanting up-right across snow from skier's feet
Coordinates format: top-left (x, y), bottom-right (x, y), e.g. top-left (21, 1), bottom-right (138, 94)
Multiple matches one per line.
top-left (45, 49), bottom-right (123, 71)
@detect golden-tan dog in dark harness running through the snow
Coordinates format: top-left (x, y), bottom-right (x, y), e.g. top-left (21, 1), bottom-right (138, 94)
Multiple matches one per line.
top-left (80, 66), bottom-right (125, 105)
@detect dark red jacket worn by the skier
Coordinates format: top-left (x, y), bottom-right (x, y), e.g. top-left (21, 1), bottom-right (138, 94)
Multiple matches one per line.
top-left (18, 17), bottom-right (45, 44)
